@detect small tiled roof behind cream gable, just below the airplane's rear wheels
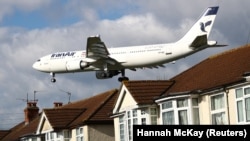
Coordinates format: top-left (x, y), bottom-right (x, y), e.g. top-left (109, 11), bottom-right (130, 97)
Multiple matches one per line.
top-left (123, 80), bottom-right (174, 104)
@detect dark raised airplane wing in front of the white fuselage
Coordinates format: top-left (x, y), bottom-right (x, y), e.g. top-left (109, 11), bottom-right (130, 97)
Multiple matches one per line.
top-left (86, 36), bottom-right (118, 65)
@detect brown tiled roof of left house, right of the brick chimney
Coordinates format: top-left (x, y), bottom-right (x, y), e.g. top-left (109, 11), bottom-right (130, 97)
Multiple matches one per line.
top-left (44, 89), bottom-right (118, 129)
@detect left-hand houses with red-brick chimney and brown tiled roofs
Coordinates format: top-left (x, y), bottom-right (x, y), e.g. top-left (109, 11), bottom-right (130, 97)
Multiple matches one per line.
top-left (0, 89), bottom-right (118, 141)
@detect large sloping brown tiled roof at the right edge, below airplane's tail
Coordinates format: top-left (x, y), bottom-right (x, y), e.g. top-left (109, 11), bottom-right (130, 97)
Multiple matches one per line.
top-left (166, 45), bottom-right (250, 94)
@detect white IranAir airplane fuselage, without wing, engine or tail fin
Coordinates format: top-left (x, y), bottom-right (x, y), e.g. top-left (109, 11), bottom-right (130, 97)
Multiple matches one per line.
top-left (33, 43), bottom-right (196, 73)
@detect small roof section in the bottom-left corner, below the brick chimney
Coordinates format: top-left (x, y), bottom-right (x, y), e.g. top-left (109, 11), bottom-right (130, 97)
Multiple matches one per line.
top-left (1, 114), bottom-right (40, 141)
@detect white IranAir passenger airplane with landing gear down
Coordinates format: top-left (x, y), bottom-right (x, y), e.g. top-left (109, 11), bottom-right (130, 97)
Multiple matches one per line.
top-left (32, 6), bottom-right (227, 83)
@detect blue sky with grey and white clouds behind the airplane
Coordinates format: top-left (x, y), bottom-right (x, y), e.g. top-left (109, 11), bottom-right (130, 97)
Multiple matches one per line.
top-left (0, 0), bottom-right (250, 129)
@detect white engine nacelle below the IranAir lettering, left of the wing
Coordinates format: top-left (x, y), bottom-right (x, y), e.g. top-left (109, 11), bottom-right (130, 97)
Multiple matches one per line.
top-left (66, 60), bottom-right (88, 71)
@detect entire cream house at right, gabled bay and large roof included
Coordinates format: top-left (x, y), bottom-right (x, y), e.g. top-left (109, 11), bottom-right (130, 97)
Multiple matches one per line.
top-left (112, 45), bottom-right (250, 141)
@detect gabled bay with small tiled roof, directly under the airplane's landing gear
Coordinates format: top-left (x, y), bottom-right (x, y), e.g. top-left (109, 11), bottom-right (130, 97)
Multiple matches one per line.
top-left (112, 80), bottom-right (174, 141)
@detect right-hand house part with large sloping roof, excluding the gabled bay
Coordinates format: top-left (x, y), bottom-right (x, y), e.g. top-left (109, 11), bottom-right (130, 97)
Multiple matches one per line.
top-left (155, 45), bottom-right (250, 125)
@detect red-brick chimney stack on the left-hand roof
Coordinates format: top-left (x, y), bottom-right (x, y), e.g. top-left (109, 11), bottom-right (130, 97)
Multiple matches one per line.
top-left (24, 102), bottom-right (39, 124)
